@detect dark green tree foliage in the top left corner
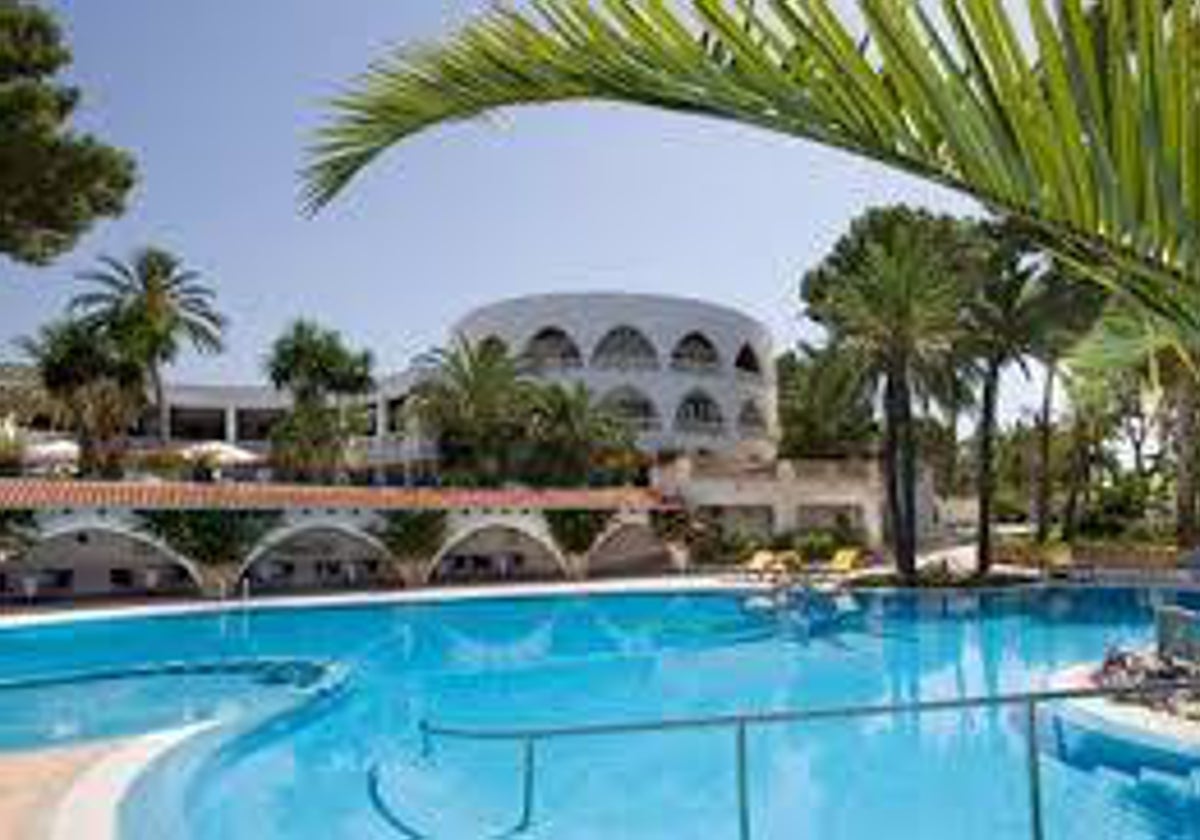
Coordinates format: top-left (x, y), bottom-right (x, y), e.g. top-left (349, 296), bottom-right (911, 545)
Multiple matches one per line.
top-left (0, 0), bottom-right (136, 264)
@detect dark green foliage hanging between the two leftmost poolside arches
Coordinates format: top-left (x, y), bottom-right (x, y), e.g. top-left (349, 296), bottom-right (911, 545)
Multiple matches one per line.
top-left (138, 509), bottom-right (282, 566)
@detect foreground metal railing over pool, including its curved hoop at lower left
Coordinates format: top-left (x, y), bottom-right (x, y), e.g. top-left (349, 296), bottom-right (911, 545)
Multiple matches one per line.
top-left (368, 680), bottom-right (1200, 840)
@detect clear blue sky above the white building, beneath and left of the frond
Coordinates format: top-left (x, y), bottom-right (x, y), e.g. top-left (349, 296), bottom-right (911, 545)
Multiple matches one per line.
top-left (0, 0), bottom-right (976, 393)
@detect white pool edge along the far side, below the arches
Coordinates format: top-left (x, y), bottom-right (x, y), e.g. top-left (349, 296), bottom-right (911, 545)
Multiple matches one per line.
top-left (0, 575), bottom-right (762, 630)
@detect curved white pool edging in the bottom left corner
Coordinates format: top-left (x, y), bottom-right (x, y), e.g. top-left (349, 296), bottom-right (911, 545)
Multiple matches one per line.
top-left (47, 724), bottom-right (212, 840)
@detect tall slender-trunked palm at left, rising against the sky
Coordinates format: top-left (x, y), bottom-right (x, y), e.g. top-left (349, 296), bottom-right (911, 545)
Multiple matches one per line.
top-left (71, 247), bottom-right (226, 444)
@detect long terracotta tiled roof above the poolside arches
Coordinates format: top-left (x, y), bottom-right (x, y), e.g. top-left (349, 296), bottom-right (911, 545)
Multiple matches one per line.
top-left (0, 479), bottom-right (674, 511)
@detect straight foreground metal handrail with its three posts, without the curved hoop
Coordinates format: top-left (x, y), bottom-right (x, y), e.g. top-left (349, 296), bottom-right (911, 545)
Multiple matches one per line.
top-left (398, 679), bottom-right (1200, 840)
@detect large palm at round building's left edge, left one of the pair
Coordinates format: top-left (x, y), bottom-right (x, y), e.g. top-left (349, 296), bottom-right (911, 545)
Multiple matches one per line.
top-left (410, 340), bottom-right (533, 486)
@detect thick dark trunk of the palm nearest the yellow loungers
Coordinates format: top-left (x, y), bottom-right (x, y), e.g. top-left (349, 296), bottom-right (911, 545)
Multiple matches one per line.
top-left (883, 371), bottom-right (917, 583)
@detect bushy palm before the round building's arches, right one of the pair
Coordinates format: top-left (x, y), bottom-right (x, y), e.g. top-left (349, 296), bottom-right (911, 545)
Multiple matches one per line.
top-left (522, 384), bottom-right (634, 486)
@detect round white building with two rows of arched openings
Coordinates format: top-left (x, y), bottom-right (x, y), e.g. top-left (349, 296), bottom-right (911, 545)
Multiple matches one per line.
top-left (454, 293), bottom-right (778, 461)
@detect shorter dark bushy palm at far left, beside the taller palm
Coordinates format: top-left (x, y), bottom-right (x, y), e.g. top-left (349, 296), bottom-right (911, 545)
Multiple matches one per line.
top-left (18, 320), bottom-right (145, 476)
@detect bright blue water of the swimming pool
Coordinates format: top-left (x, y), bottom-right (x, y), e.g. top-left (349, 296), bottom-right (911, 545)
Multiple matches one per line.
top-left (0, 589), bottom-right (1200, 840)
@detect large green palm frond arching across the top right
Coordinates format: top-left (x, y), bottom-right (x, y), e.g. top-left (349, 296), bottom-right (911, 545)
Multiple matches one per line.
top-left (306, 0), bottom-right (1200, 330)
